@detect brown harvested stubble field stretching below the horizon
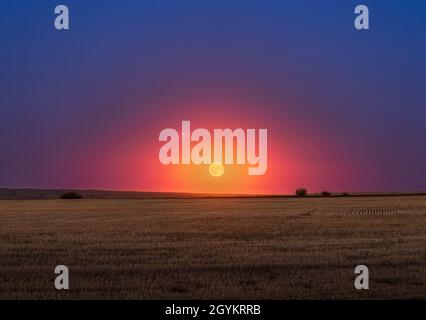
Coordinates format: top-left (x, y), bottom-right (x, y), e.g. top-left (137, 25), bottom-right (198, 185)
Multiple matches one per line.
top-left (0, 196), bottom-right (426, 299)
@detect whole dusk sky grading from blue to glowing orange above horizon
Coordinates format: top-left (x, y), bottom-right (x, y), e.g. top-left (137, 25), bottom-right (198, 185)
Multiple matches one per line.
top-left (0, 0), bottom-right (426, 193)
